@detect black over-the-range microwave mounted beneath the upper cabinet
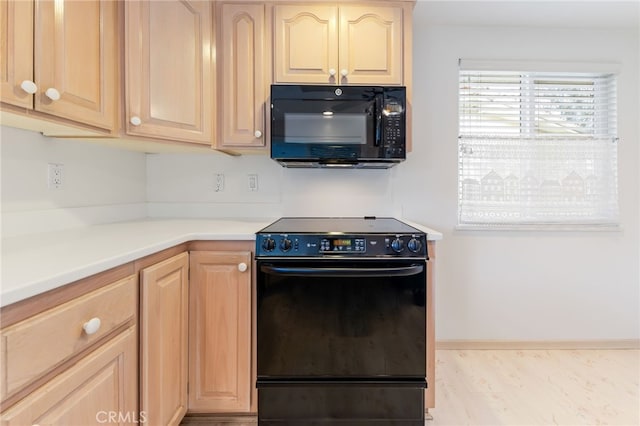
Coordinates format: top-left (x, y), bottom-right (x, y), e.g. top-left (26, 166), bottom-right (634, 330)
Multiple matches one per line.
top-left (271, 85), bottom-right (406, 168)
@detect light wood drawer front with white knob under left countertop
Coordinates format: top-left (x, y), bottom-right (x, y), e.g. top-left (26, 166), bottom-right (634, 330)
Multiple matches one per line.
top-left (0, 275), bottom-right (137, 400)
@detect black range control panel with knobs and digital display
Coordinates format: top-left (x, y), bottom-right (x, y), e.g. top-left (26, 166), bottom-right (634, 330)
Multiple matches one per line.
top-left (256, 233), bottom-right (427, 258)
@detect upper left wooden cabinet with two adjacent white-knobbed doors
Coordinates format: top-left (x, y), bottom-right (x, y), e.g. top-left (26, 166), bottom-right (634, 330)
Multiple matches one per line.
top-left (0, 0), bottom-right (119, 132)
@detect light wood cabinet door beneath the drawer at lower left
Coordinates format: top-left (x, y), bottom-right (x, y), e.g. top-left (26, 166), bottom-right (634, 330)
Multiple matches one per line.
top-left (2, 327), bottom-right (138, 426)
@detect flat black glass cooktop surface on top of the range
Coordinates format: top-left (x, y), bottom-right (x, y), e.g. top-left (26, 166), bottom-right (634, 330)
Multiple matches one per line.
top-left (259, 217), bottom-right (422, 234)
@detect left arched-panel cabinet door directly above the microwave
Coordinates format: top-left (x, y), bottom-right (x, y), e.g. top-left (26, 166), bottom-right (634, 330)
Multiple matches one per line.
top-left (274, 5), bottom-right (338, 84)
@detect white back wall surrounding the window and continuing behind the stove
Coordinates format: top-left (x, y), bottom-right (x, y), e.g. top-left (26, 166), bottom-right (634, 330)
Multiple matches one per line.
top-left (147, 1), bottom-right (640, 340)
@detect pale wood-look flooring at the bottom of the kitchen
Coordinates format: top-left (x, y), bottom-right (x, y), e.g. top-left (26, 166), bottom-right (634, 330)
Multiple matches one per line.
top-left (182, 349), bottom-right (640, 426)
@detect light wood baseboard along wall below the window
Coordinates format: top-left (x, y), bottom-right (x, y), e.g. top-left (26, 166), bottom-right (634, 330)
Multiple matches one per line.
top-left (436, 339), bottom-right (640, 350)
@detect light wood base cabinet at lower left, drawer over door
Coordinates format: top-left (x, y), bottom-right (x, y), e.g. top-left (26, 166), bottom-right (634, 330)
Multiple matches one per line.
top-left (0, 274), bottom-right (138, 425)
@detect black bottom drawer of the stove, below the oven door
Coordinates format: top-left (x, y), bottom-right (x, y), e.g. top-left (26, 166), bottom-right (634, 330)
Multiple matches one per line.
top-left (258, 384), bottom-right (424, 426)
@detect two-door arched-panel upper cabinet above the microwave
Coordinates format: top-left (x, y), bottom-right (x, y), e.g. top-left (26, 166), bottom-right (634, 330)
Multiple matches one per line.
top-left (274, 3), bottom-right (409, 85)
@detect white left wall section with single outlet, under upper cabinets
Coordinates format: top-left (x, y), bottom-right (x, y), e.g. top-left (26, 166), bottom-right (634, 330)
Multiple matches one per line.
top-left (0, 126), bottom-right (146, 237)
